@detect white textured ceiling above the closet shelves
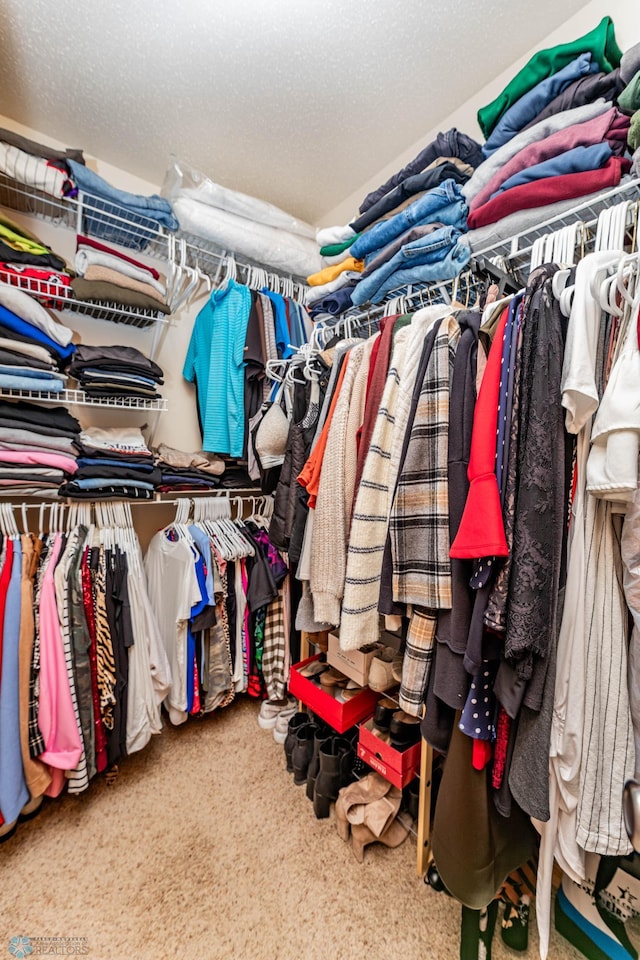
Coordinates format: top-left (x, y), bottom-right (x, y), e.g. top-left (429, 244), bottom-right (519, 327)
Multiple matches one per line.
top-left (0, 0), bottom-right (583, 223)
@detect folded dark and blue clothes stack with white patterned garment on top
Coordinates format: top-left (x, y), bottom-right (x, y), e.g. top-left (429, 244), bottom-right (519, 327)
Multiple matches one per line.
top-left (59, 427), bottom-right (161, 500)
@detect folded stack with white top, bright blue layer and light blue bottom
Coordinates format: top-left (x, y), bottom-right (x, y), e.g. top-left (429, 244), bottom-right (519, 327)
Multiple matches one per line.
top-left (0, 283), bottom-right (76, 393)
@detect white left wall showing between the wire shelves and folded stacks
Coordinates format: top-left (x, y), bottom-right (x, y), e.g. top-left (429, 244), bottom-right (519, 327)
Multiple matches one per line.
top-left (0, 117), bottom-right (205, 450)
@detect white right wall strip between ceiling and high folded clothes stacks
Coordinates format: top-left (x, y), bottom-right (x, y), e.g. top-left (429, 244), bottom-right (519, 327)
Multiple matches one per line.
top-left (318, 0), bottom-right (640, 226)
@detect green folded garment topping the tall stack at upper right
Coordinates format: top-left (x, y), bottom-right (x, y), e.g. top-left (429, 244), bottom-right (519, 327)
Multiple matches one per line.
top-left (478, 17), bottom-right (622, 137)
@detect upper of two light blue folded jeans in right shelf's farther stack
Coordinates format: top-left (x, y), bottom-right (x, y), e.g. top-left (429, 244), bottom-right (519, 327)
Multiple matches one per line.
top-left (349, 180), bottom-right (469, 260)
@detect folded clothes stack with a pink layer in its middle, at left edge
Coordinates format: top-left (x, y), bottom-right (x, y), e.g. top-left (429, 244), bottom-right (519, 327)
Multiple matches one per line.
top-left (0, 400), bottom-right (81, 496)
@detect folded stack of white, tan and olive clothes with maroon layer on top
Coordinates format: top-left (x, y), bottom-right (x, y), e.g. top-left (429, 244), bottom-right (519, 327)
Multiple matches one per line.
top-left (71, 236), bottom-right (171, 313)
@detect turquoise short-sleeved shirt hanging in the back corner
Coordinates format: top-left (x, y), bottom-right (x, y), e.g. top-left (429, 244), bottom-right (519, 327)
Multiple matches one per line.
top-left (182, 280), bottom-right (251, 457)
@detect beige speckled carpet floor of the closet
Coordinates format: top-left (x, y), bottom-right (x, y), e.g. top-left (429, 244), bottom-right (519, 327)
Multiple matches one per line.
top-left (0, 700), bottom-right (612, 960)
